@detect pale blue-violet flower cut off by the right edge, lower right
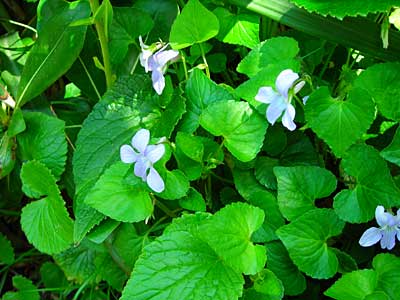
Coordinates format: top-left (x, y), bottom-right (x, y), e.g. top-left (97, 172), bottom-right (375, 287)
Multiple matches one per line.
top-left (359, 205), bottom-right (400, 250)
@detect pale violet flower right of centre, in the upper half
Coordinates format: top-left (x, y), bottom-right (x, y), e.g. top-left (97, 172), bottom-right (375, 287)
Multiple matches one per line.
top-left (255, 69), bottom-right (305, 131)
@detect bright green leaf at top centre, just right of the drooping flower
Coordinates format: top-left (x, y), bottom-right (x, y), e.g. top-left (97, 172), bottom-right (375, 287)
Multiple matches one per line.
top-left (169, 0), bottom-right (219, 49)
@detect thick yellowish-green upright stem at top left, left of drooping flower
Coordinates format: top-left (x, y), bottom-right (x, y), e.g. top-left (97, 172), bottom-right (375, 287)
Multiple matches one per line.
top-left (90, 0), bottom-right (113, 88)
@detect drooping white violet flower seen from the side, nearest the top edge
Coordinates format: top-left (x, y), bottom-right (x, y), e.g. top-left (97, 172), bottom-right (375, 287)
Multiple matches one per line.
top-left (139, 37), bottom-right (179, 95)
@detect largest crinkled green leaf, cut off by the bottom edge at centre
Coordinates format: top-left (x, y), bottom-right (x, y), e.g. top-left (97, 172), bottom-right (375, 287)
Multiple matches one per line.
top-left (121, 213), bottom-right (244, 300)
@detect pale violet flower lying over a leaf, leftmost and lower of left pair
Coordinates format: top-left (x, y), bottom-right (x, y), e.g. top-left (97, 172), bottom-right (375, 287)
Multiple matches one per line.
top-left (120, 129), bottom-right (165, 193)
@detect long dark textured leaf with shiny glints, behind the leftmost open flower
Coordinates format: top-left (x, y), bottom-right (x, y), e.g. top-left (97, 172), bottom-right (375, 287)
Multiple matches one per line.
top-left (73, 75), bottom-right (184, 241)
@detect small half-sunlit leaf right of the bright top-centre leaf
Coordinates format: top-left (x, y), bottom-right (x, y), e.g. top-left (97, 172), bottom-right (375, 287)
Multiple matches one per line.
top-left (213, 7), bottom-right (260, 48)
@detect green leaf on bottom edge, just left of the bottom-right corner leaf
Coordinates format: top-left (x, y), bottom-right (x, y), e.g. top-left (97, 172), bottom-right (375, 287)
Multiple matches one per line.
top-left (324, 270), bottom-right (377, 300)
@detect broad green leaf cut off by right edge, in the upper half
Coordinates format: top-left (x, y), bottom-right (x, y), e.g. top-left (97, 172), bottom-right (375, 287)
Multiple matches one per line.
top-left (354, 63), bottom-right (400, 121)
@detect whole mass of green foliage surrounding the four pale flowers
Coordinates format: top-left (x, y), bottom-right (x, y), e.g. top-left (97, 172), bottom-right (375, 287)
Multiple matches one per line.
top-left (0, 0), bottom-right (400, 300)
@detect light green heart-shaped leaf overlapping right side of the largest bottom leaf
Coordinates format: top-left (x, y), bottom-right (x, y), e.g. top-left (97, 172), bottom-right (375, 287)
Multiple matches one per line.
top-left (200, 202), bottom-right (267, 274)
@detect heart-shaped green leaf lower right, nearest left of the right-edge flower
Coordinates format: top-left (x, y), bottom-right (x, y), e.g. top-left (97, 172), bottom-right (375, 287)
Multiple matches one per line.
top-left (276, 209), bottom-right (345, 279)
